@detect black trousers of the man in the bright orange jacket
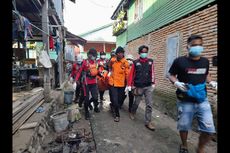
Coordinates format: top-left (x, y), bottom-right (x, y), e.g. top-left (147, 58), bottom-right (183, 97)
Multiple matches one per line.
top-left (111, 87), bottom-right (125, 117)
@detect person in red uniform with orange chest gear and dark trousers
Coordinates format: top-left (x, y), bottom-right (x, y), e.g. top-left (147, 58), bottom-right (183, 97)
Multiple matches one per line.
top-left (76, 48), bottom-right (100, 120)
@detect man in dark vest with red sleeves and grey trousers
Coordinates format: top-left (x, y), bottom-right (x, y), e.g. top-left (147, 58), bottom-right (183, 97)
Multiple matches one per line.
top-left (127, 45), bottom-right (155, 131)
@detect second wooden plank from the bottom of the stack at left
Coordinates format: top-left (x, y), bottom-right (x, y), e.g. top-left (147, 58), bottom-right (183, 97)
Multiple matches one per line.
top-left (13, 94), bottom-right (44, 124)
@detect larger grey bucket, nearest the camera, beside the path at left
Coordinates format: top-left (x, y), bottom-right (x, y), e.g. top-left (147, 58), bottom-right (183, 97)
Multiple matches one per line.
top-left (50, 111), bottom-right (69, 132)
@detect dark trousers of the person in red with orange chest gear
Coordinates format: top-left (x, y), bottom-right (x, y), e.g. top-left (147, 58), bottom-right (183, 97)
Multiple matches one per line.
top-left (84, 84), bottom-right (98, 112)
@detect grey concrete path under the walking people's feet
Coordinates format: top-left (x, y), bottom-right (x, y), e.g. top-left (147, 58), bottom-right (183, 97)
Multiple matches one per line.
top-left (90, 91), bottom-right (217, 153)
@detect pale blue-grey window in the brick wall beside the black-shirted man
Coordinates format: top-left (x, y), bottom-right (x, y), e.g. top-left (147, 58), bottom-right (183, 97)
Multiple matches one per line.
top-left (165, 33), bottom-right (180, 77)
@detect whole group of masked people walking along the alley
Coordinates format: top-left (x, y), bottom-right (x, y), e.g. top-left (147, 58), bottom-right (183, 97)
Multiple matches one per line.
top-left (69, 35), bottom-right (217, 153)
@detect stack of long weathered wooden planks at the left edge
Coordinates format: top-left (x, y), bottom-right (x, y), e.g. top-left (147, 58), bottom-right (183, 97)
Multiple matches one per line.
top-left (13, 87), bottom-right (44, 134)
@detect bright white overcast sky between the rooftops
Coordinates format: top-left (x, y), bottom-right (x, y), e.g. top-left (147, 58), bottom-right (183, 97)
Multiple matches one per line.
top-left (63, 0), bottom-right (121, 35)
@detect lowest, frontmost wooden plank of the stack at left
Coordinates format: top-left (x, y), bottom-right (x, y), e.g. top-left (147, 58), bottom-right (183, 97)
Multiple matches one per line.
top-left (12, 100), bottom-right (45, 134)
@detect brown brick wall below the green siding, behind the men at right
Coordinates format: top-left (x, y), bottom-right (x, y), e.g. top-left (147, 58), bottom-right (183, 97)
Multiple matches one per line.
top-left (127, 5), bottom-right (217, 111)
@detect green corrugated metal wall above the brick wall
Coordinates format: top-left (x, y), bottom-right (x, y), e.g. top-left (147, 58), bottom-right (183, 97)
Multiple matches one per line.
top-left (127, 0), bottom-right (215, 41)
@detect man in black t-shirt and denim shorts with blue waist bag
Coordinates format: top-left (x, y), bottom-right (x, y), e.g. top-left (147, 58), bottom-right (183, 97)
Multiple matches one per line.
top-left (169, 35), bottom-right (217, 153)
